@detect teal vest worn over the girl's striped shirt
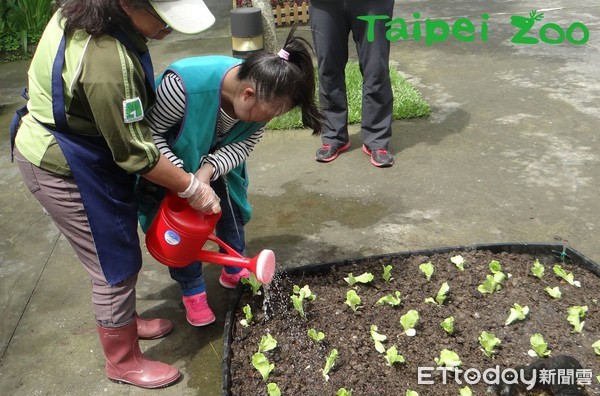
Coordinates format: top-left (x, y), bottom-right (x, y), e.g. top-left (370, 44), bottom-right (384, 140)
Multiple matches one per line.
top-left (139, 56), bottom-right (264, 231)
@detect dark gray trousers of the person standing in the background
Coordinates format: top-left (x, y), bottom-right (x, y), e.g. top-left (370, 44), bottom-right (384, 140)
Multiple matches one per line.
top-left (310, 0), bottom-right (394, 150)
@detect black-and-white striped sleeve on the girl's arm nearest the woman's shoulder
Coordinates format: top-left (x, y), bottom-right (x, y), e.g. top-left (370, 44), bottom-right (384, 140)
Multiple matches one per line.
top-left (148, 73), bottom-right (185, 168)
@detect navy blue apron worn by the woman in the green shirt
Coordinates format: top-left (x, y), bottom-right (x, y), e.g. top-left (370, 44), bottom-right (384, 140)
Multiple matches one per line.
top-left (11, 32), bottom-right (154, 286)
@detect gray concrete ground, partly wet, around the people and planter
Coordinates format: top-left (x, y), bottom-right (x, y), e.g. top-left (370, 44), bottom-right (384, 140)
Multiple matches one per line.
top-left (0, 0), bottom-right (600, 395)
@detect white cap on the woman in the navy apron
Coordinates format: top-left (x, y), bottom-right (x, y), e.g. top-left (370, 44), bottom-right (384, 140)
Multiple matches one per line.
top-left (149, 0), bottom-right (215, 34)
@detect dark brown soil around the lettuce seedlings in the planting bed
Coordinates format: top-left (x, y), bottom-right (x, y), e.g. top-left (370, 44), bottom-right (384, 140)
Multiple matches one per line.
top-left (230, 250), bottom-right (600, 396)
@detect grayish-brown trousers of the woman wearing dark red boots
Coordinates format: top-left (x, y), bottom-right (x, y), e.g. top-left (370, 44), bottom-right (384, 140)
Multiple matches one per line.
top-left (14, 149), bottom-right (137, 327)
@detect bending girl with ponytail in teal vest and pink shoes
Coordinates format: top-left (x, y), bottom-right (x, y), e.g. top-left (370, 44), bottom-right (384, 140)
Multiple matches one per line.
top-left (140, 29), bottom-right (321, 326)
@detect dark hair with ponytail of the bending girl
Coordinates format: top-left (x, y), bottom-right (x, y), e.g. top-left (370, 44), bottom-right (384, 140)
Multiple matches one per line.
top-left (238, 26), bottom-right (323, 135)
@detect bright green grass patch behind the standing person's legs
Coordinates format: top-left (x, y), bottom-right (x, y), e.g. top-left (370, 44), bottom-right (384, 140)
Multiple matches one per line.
top-left (267, 62), bottom-right (431, 129)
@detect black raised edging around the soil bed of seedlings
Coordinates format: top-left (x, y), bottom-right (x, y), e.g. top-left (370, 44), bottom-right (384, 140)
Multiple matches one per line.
top-left (221, 242), bottom-right (600, 396)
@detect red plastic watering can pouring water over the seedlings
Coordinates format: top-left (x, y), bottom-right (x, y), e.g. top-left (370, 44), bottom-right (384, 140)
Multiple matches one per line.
top-left (146, 194), bottom-right (275, 284)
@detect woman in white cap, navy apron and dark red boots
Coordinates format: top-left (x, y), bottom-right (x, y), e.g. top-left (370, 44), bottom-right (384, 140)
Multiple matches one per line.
top-left (12, 0), bottom-right (220, 388)
